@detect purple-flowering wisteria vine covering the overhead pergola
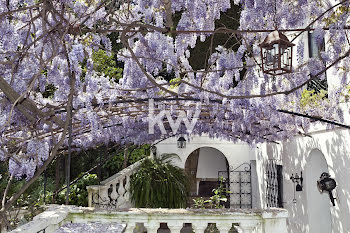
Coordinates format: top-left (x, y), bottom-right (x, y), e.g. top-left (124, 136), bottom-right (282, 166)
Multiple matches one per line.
top-left (0, 0), bottom-right (350, 215)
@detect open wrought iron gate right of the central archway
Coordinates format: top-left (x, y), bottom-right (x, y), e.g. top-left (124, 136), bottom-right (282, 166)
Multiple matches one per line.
top-left (218, 163), bottom-right (252, 208)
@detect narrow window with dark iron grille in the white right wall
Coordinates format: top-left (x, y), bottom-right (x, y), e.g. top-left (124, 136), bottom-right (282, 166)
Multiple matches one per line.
top-left (265, 160), bottom-right (283, 208)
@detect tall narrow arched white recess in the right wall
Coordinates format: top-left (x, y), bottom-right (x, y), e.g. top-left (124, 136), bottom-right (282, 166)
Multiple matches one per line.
top-left (305, 150), bottom-right (332, 233)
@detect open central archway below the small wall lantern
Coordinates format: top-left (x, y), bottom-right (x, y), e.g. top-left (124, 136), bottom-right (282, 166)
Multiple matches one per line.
top-left (185, 147), bottom-right (229, 197)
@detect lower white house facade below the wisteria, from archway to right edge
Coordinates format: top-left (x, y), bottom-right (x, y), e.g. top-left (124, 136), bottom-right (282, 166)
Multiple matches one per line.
top-left (157, 124), bottom-right (350, 233)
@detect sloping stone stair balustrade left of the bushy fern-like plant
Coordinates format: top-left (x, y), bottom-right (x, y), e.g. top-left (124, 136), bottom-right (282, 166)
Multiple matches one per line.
top-left (86, 160), bottom-right (143, 208)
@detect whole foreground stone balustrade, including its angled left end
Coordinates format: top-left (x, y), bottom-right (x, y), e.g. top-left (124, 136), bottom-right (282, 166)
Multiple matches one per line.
top-left (9, 206), bottom-right (288, 233)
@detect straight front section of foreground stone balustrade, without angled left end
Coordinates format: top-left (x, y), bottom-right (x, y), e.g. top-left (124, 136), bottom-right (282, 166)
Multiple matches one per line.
top-left (80, 208), bottom-right (288, 233)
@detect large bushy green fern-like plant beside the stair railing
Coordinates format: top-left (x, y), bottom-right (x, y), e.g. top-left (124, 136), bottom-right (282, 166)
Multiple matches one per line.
top-left (130, 154), bottom-right (189, 208)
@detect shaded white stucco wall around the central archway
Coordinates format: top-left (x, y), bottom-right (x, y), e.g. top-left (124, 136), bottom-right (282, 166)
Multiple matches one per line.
top-left (156, 136), bottom-right (261, 208)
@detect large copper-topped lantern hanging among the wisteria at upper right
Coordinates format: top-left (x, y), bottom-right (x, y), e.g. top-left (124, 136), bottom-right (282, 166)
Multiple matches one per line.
top-left (259, 31), bottom-right (294, 75)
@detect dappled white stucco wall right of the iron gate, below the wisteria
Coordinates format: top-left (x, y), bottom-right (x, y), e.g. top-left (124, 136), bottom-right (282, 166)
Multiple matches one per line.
top-left (256, 129), bottom-right (350, 233)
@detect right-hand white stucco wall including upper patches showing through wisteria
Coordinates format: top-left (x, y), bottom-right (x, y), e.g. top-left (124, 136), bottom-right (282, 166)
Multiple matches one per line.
top-left (256, 24), bottom-right (350, 233)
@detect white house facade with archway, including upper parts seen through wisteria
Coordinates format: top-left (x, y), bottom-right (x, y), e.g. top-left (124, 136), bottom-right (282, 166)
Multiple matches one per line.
top-left (156, 25), bottom-right (350, 233)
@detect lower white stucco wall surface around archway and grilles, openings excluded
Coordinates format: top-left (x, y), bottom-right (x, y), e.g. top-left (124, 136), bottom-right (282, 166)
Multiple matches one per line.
top-left (157, 124), bottom-right (350, 233)
